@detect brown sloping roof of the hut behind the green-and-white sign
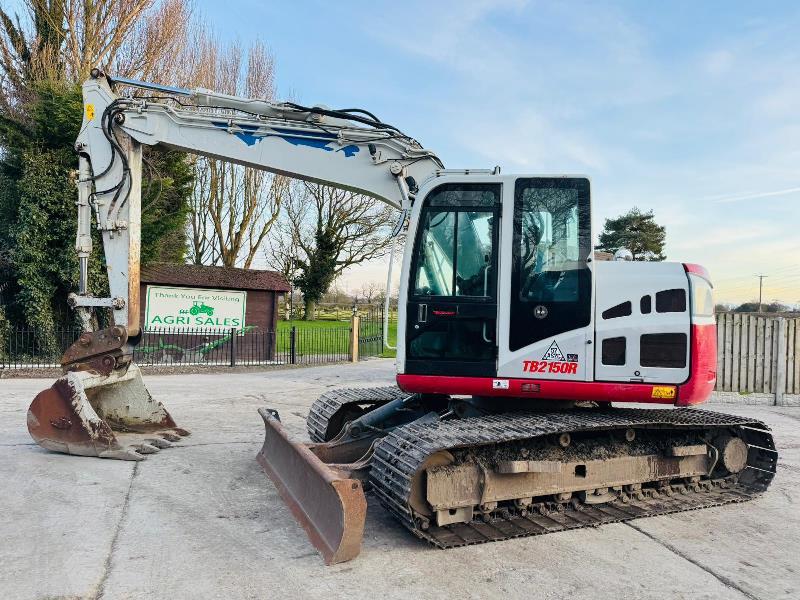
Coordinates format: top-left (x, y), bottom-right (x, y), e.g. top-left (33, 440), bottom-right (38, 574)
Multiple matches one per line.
top-left (141, 263), bottom-right (290, 292)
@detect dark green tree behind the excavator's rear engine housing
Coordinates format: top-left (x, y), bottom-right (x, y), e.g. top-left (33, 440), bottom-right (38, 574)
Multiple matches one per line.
top-left (596, 206), bottom-right (667, 261)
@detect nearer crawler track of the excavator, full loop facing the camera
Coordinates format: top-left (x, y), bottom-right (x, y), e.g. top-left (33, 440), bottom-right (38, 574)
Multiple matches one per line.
top-left (370, 408), bottom-right (777, 548)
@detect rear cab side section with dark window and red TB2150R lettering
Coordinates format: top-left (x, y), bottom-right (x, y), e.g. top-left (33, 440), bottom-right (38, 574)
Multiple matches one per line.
top-left (498, 177), bottom-right (593, 381)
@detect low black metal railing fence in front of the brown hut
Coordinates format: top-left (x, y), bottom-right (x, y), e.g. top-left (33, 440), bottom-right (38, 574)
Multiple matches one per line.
top-left (0, 308), bottom-right (383, 369)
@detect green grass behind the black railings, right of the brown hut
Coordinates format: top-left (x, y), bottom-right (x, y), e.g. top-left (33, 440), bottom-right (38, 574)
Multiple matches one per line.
top-left (278, 319), bottom-right (397, 358)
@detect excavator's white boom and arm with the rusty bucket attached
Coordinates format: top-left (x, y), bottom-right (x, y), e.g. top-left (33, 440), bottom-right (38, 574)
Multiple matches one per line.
top-left (28, 70), bottom-right (443, 460)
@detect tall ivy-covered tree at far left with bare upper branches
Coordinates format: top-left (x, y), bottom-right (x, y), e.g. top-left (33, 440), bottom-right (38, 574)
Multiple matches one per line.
top-left (0, 0), bottom-right (198, 346)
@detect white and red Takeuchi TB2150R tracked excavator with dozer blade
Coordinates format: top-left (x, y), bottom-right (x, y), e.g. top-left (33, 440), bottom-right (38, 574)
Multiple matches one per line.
top-left (28, 70), bottom-right (777, 564)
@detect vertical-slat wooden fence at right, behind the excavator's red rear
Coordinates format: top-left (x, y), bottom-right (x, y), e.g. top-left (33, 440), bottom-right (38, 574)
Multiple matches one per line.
top-left (716, 313), bottom-right (800, 401)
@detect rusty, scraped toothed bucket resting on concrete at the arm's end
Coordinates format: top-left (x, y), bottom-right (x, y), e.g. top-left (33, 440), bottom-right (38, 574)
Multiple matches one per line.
top-left (28, 364), bottom-right (189, 460)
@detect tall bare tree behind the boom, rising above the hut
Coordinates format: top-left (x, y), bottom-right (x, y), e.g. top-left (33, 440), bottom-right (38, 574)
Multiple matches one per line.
top-left (188, 39), bottom-right (288, 268)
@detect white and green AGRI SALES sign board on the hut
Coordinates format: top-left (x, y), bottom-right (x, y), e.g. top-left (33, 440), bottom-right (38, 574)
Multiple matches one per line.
top-left (144, 285), bottom-right (247, 331)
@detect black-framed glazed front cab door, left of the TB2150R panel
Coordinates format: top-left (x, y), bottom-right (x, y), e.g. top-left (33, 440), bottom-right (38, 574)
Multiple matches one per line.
top-left (405, 183), bottom-right (502, 377)
